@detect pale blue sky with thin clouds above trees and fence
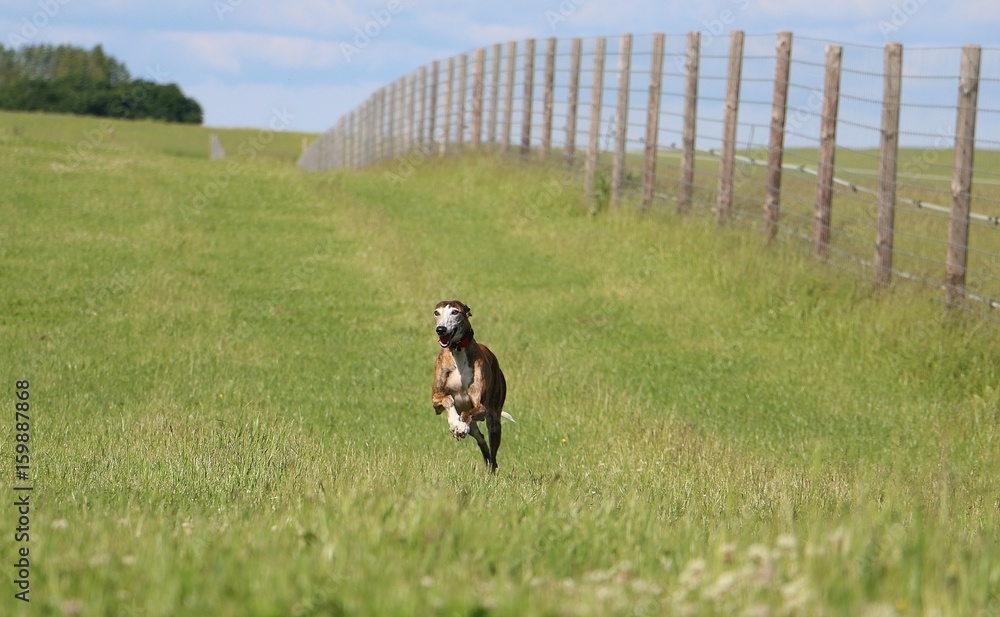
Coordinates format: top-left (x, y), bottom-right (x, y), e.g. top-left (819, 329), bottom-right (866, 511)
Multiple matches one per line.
top-left (0, 0), bottom-right (1000, 131)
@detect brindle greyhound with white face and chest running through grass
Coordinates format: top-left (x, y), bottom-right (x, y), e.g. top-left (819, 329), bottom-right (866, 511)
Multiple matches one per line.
top-left (431, 300), bottom-right (514, 473)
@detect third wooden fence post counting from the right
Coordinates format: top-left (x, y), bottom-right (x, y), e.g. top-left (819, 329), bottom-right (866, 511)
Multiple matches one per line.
top-left (813, 45), bottom-right (843, 257)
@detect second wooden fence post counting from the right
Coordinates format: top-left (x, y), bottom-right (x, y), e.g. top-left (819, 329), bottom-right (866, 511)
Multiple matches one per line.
top-left (874, 43), bottom-right (903, 286)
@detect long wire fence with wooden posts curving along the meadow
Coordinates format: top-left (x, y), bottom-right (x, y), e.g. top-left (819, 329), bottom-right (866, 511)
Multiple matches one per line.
top-left (299, 31), bottom-right (1000, 315)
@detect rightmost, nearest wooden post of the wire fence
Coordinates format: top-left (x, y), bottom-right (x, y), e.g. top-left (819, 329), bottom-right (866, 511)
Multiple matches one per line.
top-left (946, 45), bottom-right (982, 308)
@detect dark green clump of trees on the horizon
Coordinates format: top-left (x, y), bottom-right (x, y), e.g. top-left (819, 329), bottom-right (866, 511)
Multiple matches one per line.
top-left (0, 44), bottom-right (203, 124)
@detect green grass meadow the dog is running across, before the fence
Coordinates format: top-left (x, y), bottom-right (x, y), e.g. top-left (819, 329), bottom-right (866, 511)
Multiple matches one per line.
top-left (0, 114), bottom-right (1000, 616)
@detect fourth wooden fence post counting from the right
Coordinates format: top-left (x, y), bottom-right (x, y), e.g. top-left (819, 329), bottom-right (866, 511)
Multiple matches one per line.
top-left (764, 32), bottom-right (792, 240)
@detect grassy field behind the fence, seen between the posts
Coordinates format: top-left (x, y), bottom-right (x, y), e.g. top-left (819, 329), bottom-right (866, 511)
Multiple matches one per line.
top-left (608, 141), bottom-right (1000, 304)
